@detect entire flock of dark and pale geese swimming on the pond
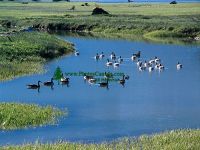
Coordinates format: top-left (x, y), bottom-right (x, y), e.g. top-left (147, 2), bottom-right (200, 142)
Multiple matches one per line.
top-left (27, 51), bottom-right (183, 89)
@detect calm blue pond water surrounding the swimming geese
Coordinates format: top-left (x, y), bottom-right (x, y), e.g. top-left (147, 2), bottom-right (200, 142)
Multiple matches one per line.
top-left (0, 35), bottom-right (200, 145)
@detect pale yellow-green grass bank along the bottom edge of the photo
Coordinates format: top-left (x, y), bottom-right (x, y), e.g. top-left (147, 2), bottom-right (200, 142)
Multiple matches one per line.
top-left (2, 130), bottom-right (200, 150)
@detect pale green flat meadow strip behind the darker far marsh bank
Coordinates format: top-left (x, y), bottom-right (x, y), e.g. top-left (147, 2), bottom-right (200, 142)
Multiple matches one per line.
top-left (0, 2), bottom-right (200, 18)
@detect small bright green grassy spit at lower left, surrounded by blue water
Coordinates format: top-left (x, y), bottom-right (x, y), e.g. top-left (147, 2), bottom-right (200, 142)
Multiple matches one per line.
top-left (0, 103), bottom-right (64, 130)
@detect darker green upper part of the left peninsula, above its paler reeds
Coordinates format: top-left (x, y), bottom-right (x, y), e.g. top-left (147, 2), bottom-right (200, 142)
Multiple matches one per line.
top-left (0, 32), bottom-right (73, 61)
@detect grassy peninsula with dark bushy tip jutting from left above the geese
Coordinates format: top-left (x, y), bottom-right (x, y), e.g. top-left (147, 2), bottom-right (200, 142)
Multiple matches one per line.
top-left (0, 32), bottom-right (74, 81)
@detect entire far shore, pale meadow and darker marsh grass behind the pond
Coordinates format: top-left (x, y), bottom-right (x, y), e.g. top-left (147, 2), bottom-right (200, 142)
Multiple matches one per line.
top-left (0, 2), bottom-right (200, 40)
